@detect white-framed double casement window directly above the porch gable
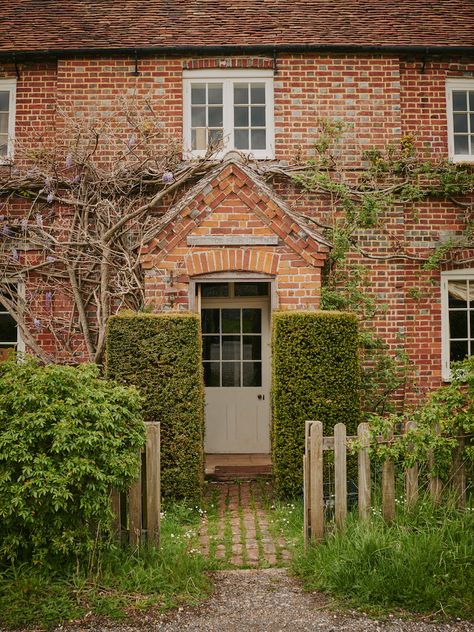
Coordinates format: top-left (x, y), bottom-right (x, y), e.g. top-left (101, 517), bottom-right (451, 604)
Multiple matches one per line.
top-left (183, 70), bottom-right (274, 158)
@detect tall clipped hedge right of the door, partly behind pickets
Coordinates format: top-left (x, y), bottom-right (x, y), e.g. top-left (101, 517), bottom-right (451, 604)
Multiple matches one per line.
top-left (272, 311), bottom-right (360, 497)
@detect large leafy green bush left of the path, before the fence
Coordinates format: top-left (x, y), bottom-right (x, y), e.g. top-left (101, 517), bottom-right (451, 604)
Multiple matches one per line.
top-left (0, 359), bottom-right (144, 564)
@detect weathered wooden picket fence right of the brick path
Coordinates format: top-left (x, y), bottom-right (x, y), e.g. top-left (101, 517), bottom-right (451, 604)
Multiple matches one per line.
top-left (303, 421), bottom-right (466, 546)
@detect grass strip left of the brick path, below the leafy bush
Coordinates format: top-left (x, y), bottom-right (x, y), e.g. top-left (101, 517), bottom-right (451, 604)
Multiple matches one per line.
top-left (0, 506), bottom-right (211, 629)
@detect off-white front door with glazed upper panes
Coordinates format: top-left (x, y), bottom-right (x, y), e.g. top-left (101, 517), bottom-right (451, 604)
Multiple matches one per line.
top-left (201, 298), bottom-right (270, 454)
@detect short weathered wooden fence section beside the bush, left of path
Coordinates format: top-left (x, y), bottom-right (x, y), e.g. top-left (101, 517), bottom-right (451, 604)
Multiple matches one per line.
top-left (111, 422), bottom-right (161, 548)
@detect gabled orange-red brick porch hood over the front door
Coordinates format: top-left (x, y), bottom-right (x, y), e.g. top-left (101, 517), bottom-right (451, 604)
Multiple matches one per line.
top-left (141, 159), bottom-right (331, 312)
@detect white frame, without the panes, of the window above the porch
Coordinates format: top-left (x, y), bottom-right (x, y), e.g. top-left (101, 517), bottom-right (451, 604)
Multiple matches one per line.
top-left (183, 69), bottom-right (275, 160)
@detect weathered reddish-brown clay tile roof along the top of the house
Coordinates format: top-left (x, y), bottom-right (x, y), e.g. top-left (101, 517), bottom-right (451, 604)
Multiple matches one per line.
top-left (0, 0), bottom-right (474, 53)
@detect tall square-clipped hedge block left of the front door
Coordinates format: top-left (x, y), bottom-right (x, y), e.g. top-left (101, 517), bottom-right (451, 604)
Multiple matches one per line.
top-left (107, 312), bottom-right (204, 501)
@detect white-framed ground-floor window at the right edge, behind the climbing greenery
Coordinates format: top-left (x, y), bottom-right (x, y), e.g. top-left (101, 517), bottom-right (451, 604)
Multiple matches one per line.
top-left (441, 268), bottom-right (474, 380)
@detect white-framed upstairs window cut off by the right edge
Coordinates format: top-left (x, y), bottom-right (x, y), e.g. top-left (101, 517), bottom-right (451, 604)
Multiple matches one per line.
top-left (446, 78), bottom-right (474, 162)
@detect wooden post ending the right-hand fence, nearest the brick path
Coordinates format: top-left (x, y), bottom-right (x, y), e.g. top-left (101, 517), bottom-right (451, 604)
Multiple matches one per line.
top-left (310, 421), bottom-right (324, 542)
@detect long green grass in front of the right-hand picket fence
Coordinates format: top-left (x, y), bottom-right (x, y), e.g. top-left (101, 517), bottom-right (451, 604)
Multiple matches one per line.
top-left (278, 499), bottom-right (474, 619)
